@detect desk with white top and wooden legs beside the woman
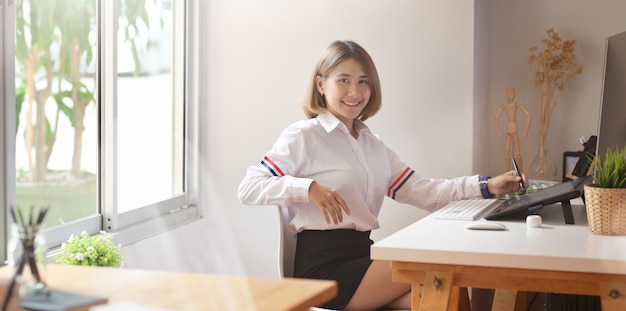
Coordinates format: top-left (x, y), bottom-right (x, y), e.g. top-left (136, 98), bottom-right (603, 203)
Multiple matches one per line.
top-left (372, 202), bottom-right (626, 311)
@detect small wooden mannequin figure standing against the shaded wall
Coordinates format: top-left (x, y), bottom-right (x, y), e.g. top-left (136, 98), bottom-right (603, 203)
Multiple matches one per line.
top-left (493, 87), bottom-right (532, 172)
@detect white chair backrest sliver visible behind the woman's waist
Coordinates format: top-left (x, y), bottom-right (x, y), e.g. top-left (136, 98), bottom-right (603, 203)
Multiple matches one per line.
top-left (278, 206), bottom-right (297, 278)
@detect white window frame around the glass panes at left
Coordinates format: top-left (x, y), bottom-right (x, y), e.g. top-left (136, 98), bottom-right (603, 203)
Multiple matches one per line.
top-left (0, 0), bottom-right (200, 254)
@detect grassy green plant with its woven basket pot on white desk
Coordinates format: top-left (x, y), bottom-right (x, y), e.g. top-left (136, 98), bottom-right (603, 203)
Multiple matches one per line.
top-left (584, 146), bottom-right (626, 235)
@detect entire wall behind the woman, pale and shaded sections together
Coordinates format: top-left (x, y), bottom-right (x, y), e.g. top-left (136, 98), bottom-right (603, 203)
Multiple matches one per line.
top-left (119, 0), bottom-right (626, 276)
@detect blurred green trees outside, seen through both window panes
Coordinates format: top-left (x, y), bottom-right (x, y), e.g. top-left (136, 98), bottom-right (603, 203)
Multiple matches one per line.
top-left (15, 0), bottom-right (160, 183)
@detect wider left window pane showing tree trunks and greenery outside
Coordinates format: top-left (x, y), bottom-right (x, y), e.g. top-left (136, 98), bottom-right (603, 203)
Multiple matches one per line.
top-left (15, 0), bottom-right (98, 227)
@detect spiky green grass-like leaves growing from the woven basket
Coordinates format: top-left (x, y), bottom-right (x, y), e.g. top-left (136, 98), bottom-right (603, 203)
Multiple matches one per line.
top-left (593, 146), bottom-right (626, 188)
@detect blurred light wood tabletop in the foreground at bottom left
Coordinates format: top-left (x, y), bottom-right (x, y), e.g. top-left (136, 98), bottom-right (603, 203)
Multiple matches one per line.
top-left (0, 264), bottom-right (337, 311)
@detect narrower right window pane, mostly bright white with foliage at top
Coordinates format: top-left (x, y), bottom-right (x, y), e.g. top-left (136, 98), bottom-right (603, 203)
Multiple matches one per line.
top-left (116, 0), bottom-right (183, 212)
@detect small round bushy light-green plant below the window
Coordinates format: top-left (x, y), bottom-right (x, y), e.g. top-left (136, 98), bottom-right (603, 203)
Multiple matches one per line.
top-left (56, 231), bottom-right (123, 267)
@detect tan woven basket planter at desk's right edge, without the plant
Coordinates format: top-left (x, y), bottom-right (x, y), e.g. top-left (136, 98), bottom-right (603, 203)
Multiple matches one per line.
top-left (585, 184), bottom-right (626, 235)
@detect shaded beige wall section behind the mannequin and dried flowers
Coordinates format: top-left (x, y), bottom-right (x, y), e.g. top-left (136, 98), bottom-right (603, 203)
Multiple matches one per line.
top-left (475, 0), bottom-right (626, 178)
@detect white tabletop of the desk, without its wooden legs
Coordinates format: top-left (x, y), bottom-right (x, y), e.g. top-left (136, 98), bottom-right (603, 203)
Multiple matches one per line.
top-left (372, 200), bottom-right (626, 274)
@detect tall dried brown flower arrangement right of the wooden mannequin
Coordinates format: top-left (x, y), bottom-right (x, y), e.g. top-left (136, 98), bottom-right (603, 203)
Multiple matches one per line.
top-left (528, 28), bottom-right (583, 179)
